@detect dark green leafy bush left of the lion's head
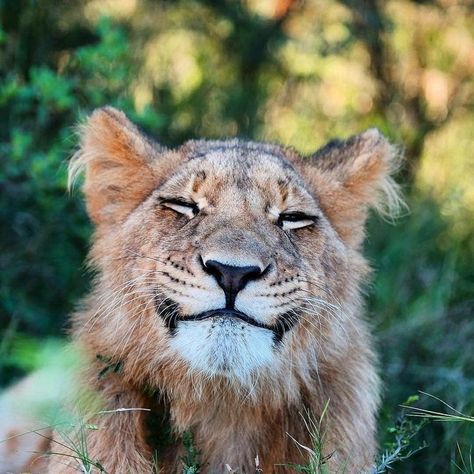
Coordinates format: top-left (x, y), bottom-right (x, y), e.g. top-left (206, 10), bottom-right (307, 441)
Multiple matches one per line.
top-left (0, 11), bottom-right (159, 348)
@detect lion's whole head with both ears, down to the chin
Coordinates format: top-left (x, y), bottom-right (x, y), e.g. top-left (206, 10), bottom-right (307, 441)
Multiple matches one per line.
top-left (73, 109), bottom-right (400, 392)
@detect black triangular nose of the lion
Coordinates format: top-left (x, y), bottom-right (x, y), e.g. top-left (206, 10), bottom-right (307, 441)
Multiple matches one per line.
top-left (202, 260), bottom-right (265, 309)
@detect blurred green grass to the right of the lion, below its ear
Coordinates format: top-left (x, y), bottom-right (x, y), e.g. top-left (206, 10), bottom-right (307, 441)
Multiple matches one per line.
top-left (367, 195), bottom-right (474, 473)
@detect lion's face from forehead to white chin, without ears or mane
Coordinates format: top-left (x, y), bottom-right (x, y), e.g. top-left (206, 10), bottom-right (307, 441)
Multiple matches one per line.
top-left (130, 142), bottom-right (325, 380)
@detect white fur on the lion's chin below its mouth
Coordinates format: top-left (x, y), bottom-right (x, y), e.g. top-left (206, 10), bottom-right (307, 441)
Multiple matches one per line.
top-left (170, 317), bottom-right (276, 385)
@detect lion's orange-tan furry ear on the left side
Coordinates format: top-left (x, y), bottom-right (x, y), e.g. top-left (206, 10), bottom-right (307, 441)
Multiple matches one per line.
top-left (69, 107), bottom-right (164, 224)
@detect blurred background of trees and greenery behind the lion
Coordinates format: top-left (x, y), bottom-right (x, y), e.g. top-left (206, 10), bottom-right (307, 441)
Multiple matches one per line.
top-left (0, 0), bottom-right (474, 473)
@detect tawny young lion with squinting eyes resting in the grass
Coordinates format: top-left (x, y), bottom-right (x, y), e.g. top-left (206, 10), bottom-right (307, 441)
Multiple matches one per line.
top-left (13, 107), bottom-right (399, 474)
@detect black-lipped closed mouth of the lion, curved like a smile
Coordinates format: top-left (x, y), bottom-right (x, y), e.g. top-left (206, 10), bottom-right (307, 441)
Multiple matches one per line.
top-left (155, 298), bottom-right (298, 343)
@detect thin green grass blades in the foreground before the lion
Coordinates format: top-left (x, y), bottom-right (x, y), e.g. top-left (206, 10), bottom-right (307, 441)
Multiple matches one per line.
top-left (0, 394), bottom-right (474, 474)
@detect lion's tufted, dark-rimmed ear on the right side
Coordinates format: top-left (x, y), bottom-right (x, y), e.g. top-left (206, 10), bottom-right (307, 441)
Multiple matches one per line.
top-left (306, 129), bottom-right (403, 248)
